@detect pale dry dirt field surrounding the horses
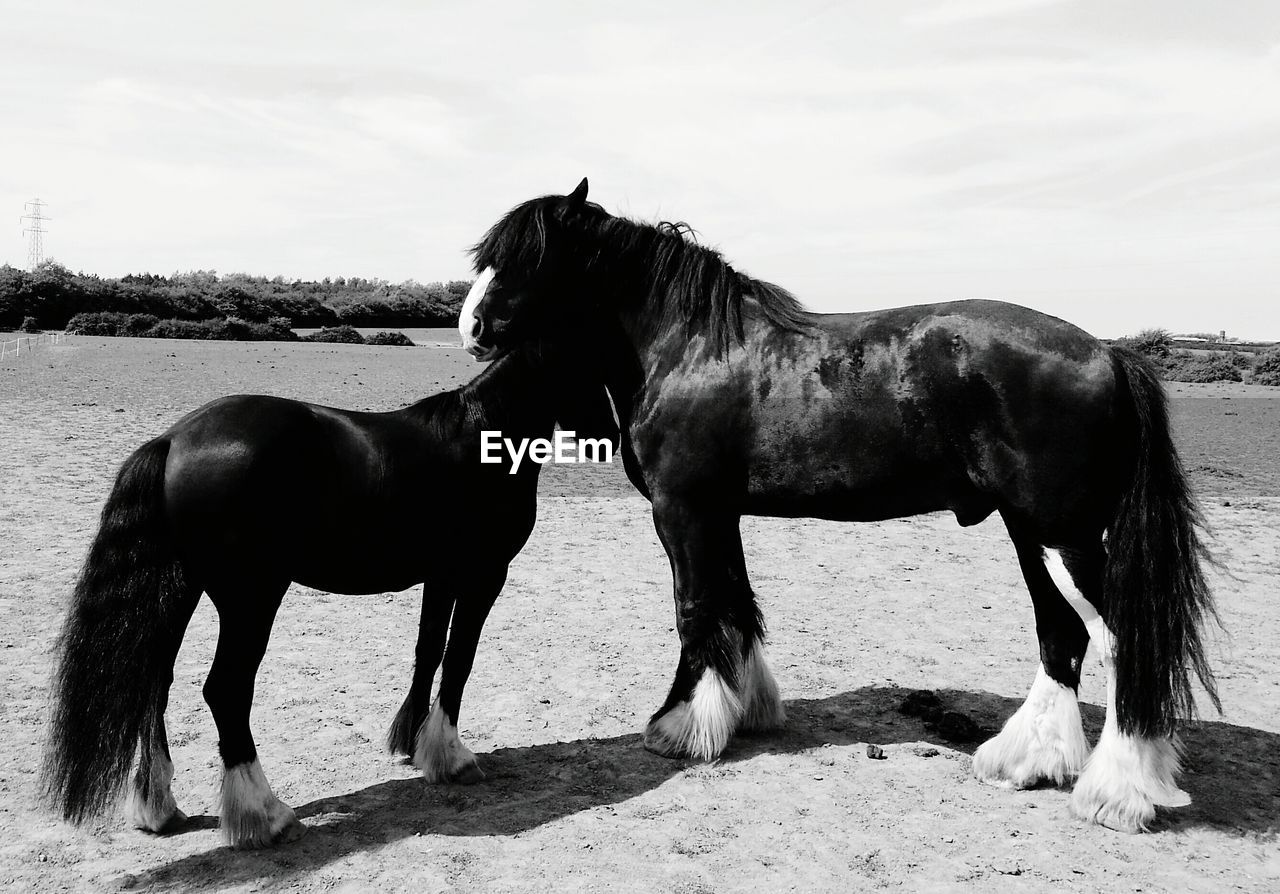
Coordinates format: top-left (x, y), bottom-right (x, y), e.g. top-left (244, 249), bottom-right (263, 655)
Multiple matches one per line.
top-left (0, 336), bottom-right (1280, 894)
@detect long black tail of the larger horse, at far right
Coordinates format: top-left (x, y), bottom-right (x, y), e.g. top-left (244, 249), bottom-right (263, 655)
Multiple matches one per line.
top-left (1102, 347), bottom-right (1222, 736)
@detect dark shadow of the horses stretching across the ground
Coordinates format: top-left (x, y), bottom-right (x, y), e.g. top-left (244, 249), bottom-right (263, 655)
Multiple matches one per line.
top-left (120, 687), bottom-right (1280, 890)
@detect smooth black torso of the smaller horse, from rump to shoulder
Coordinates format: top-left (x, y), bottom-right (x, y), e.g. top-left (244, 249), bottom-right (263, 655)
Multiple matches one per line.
top-left (164, 392), bottom-right (536, 593)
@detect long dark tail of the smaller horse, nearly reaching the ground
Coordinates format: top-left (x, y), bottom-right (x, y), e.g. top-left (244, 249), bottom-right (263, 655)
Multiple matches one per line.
top-left (42, 438), bottom-right (189, 822)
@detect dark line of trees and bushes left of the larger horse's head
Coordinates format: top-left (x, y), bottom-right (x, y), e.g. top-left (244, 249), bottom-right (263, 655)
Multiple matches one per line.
top-left (0, 261), bottom-right (471, 329)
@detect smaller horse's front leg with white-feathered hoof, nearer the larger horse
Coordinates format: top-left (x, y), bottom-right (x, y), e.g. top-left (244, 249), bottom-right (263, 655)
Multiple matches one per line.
top-left (413, 566), bottom-right (507, 785)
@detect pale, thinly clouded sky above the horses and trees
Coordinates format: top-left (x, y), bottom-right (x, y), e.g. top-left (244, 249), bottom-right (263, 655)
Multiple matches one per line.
top-left (0, 0), bottom-right (1280, 339)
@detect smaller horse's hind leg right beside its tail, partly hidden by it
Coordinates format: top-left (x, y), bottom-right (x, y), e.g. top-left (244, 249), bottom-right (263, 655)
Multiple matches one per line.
top-left (125, 589), bottom-right (200, 833)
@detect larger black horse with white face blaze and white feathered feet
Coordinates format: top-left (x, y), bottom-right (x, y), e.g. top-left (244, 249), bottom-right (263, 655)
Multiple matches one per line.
top-left (460, 179), bottom-right (1217, 830)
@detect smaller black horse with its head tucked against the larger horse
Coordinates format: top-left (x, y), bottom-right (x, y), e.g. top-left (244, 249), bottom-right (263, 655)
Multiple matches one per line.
top-left (45, 345), bottom-right (617, 847)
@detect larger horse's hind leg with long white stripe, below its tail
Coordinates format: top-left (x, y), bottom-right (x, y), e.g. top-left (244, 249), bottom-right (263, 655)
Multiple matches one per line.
top-left (1047, 546), bottom-right (1190, 833)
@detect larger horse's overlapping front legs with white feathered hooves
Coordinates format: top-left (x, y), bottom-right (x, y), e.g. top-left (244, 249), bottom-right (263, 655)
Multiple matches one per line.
top-left (644, 494), bottom-right (783, 760)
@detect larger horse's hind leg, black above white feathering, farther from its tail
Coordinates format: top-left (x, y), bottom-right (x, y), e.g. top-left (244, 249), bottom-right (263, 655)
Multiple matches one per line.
top-left (973, 525), bottom-right (1089, 789)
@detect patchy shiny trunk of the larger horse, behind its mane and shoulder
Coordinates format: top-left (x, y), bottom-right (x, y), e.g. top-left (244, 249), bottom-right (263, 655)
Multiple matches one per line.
top-left (736, 295), bottom-right (1116, 530)
